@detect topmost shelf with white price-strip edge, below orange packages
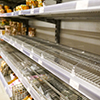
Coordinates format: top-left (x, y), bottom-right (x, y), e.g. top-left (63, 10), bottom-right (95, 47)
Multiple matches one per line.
top-left (0, 0), bottom-right (100, 18)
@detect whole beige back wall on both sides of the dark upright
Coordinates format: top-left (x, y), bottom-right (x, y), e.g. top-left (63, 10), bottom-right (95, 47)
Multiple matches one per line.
top-left (29, 20), bottom-right (100, 55)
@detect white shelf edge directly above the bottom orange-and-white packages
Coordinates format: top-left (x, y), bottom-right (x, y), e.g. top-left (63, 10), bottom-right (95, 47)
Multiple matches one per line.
top-left (1, 51), bottom-right (41, 100)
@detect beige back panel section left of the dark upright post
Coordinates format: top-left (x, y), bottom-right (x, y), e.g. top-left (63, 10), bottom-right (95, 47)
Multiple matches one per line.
top-left (29, 20), bottom-right (55, 42)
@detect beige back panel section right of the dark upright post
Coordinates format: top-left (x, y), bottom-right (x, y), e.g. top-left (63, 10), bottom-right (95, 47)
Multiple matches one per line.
top-left (61, 21), bottom-right (100, 55)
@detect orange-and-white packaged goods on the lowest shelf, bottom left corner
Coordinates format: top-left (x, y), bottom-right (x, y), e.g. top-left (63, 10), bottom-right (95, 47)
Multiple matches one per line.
top-left (0, 58), bottom-right (33, 100)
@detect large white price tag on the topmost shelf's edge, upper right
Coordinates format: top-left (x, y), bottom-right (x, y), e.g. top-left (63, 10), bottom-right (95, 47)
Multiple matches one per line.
top-left (76, 0), bottom-right (89, 10)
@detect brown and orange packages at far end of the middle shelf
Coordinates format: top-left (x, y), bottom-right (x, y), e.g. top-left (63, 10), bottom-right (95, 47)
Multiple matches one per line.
top-left (0, 19), bottom-right (36, 37)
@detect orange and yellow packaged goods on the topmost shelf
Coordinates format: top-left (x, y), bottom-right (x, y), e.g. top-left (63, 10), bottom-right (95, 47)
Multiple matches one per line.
top-left (0, 0), bottom-right (44, 14)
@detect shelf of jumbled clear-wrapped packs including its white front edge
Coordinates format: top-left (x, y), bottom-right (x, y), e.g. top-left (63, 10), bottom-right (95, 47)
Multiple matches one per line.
top-left (0, 42), bottom-right (88, 100)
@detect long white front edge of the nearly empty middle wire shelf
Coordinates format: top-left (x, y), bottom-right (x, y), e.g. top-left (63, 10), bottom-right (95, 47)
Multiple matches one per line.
top-left (0, 35), bottom-right (100, 100)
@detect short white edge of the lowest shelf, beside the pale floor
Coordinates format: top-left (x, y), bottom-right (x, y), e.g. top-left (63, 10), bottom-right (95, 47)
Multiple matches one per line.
top-left (0, 72), bottom-right (12, 97)
